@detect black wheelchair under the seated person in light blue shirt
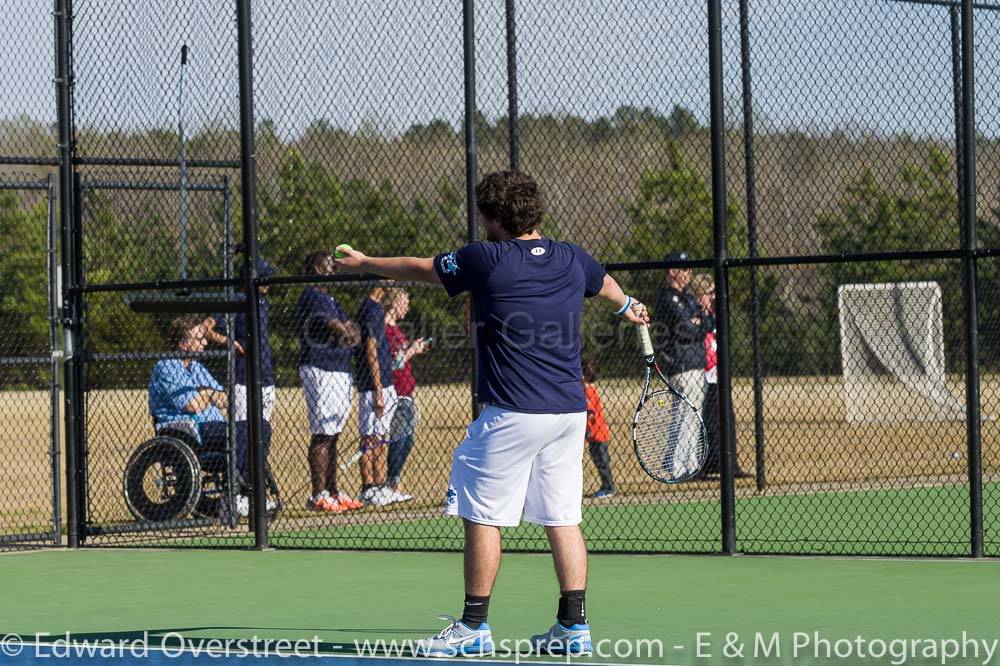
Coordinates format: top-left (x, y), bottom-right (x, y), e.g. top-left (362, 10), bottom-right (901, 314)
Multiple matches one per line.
top-left (124, 421), bottom-right (281, 523)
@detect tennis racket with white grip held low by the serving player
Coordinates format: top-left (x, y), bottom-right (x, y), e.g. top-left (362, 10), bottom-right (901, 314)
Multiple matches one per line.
top-left (632, 325), bottom-right (708, 483)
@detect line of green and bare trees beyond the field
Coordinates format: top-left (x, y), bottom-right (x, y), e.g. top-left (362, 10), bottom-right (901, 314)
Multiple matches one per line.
top-left (0, 107), bottom-right (1000, 386)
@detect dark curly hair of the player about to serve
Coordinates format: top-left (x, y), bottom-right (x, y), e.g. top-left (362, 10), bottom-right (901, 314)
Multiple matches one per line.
top-left (476, 171), bottom-right (545, 236)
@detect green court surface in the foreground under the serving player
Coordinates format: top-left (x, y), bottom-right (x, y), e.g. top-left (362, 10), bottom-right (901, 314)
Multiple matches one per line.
top-left (0, 550), bottom-right (1000, 664)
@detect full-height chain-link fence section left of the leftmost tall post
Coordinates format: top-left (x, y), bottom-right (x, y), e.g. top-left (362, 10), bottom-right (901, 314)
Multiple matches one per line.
top-left (0, 2), bottom-right (62, 550)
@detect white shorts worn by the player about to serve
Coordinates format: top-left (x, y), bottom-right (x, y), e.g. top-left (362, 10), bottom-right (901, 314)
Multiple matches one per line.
top-left (445, 405), bottom-right (587, 527)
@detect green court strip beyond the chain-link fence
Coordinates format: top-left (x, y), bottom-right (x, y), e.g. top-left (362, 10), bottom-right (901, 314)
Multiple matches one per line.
top-left (152, 484), bottom-right (988, 556)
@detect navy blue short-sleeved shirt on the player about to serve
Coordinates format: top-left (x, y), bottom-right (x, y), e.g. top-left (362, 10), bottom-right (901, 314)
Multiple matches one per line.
top-left (434, 238), bottom-right (606, 414)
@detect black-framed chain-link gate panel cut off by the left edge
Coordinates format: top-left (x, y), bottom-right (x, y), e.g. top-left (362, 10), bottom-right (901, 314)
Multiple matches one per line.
top-left (0, 176), bottom-right (61, 549)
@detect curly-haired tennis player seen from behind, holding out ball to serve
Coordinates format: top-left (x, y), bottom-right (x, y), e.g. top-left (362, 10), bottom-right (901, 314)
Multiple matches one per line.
top-left (338, 171), bottom-right (648, 656)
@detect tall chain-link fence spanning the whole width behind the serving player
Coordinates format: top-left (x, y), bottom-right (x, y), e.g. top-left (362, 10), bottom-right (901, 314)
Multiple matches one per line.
top-left (0, 0), bottom-right (1000, 555)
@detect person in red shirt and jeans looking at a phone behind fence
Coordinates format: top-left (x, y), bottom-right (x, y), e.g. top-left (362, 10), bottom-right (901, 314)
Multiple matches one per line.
top-left (385, 289), bottom-right (429, 498)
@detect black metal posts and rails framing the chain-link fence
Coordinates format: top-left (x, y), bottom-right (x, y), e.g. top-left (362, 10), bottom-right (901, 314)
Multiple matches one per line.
top-left (0, 0), bottom-right (988, 557)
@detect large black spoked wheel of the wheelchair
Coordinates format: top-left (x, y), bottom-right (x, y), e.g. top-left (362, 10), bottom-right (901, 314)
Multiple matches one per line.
top-left (125, 437), bottom-right (201, 522)
